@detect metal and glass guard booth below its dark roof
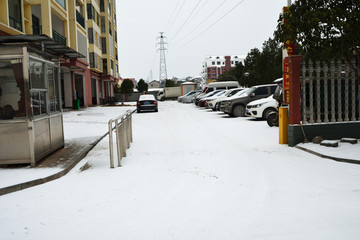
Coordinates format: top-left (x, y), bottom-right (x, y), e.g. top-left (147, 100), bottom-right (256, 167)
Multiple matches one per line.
top-left (0, 44), bottom-right (64, 166)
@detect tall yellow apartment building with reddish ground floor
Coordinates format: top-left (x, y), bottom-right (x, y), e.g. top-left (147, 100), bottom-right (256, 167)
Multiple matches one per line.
top-left (0, 0), bottom-right (119, 107)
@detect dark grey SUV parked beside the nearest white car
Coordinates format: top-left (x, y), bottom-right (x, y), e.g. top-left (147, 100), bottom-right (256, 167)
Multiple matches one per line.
top-left (220, 84), bottom-right (277, 117)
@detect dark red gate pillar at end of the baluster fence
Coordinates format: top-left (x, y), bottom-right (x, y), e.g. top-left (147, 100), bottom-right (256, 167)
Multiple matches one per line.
top-left (287, 56), bottom-right (303, 124)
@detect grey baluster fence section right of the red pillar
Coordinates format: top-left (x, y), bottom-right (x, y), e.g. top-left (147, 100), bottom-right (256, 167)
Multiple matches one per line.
top-left (301, 60), bottom-right (360, 124)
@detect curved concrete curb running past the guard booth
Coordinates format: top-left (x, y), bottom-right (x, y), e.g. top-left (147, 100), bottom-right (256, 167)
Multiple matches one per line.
top-left (0, 133), bottom-right (109, 196)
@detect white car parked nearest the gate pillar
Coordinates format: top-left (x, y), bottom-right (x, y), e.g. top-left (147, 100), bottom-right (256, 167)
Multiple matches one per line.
top-left (245, 95), bottom-right (279, 120)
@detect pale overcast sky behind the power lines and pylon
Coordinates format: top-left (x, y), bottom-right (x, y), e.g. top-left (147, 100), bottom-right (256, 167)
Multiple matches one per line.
top-left (116, 0), bottom-right (287, 80)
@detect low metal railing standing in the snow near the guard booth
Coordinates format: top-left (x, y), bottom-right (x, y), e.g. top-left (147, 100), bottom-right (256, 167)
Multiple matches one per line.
top-left (109, 110), bottom-right (134, 168)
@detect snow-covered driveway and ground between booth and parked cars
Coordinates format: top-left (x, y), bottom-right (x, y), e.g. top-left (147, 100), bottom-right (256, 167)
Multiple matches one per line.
top-left (0, 102), bottom-right (360, 240)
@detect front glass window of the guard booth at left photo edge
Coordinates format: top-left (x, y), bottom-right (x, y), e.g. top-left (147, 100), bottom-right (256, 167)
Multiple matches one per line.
top-left (0, 59), bottom-right (26, 120)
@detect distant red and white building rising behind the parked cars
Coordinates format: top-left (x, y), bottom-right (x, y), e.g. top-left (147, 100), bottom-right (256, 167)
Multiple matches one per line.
top-left (202, 55), bottom-right (244, 80)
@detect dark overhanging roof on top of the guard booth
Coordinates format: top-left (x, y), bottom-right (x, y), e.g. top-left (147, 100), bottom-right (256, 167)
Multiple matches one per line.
top-left (0, 35), bottom-right (85, 58)
